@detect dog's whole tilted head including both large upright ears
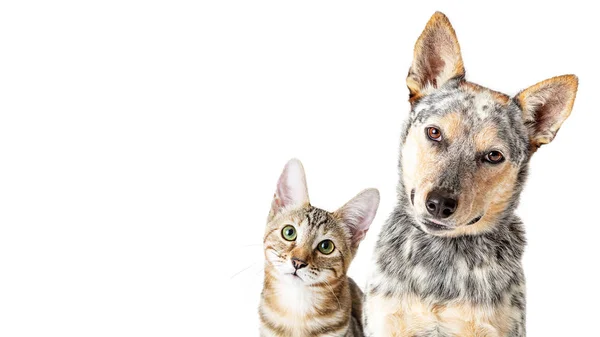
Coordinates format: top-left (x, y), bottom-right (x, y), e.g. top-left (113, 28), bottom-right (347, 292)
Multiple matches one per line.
top-left (400, 13), bottom-right (577, 236)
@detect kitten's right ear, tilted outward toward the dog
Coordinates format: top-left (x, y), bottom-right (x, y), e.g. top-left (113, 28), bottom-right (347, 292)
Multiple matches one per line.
top-left (335, 188), bottom-right (379, 244)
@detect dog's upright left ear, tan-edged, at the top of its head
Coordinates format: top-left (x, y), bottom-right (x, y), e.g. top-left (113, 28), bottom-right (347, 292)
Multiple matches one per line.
top-left (406, 12), bottom-right (465, 103)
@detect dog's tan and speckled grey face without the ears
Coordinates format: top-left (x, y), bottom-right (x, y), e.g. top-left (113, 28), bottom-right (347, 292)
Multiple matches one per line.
top-left (401, 82), bottom-right (529, 235)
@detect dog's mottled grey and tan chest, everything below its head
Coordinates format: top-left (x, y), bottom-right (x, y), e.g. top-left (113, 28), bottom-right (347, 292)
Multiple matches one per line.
top-left (365, 220), bottom-right (525, 337)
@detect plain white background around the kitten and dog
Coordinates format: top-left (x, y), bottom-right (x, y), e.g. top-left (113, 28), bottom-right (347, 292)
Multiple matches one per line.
top-left (0, 1), bottom-right (600, 336)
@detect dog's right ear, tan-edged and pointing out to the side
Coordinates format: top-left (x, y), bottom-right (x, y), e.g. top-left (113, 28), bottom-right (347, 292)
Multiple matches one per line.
top-left (515, 75), bottom-right (578, 153)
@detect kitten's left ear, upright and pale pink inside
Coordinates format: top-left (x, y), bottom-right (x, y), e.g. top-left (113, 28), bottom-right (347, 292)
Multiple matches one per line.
top-left (270, 159), bottom-right (310, 216)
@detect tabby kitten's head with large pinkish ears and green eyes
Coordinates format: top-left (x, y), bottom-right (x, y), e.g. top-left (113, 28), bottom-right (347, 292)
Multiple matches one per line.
top-left (264, 159), bottom-right (379, 285)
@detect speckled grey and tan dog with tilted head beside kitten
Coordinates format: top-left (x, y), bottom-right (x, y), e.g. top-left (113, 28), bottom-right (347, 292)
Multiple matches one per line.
top-left (363, 12), bottom-right (578, 337)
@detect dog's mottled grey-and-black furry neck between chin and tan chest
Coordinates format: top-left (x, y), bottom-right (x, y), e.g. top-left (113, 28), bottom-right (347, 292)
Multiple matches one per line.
top-left (375, 197), bottom-right (525, 304)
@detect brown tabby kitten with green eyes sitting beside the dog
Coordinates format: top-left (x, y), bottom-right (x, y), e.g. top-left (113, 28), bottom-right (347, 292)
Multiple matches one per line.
top-left (259, 159), bottom-right (379, 337)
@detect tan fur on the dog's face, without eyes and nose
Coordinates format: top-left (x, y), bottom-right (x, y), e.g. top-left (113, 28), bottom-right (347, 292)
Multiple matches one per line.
top-left (402, 112), bottom-right (519, 236)
